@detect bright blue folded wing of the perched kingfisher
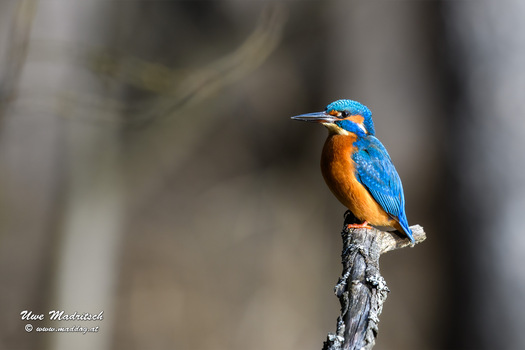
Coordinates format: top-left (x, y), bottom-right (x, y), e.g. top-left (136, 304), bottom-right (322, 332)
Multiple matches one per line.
top-left (352, 136), bottom-right (414, 241)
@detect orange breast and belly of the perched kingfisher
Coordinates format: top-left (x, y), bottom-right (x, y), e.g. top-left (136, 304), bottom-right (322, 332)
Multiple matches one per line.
top-left (321, 134), bottom-right (399, 228)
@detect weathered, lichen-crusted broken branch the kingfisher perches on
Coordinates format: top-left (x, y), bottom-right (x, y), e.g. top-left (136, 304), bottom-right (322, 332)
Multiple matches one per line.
top-left (323, 215), bottom-right (426, 350)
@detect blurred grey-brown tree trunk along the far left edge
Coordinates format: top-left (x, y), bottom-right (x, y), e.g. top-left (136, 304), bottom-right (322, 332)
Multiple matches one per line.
top-left (0, 0), bottom-right (51, 349)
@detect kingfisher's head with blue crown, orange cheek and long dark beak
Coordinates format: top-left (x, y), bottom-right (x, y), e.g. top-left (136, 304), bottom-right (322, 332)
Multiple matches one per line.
top-left (292, 100), bottom-right (375, 136)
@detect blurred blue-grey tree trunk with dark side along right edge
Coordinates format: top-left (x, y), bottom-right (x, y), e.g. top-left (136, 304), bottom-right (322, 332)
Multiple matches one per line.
top-left (444, 0), bottom-right (525, 349)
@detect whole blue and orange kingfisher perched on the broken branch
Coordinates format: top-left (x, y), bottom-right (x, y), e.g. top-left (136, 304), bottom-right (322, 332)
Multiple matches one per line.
top-left (292, 100), bottom-right (414, 243)
